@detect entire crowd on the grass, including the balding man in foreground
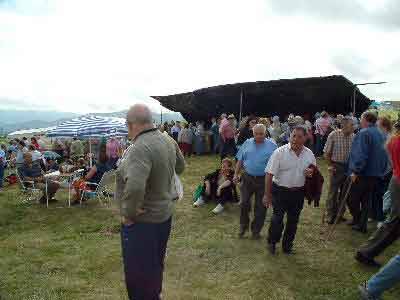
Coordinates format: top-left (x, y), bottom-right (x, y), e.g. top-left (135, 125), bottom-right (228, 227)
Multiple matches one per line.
top-left (0, 105), bottom-right (400, 299)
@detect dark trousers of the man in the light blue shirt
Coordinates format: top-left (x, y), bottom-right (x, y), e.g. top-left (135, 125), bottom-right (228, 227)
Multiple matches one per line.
top-left (240, 173), bottom-right (267, 234)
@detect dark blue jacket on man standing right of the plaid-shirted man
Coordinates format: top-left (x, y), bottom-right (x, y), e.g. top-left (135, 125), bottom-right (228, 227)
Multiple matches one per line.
top-left (349, 126), bottom-right (388, 177)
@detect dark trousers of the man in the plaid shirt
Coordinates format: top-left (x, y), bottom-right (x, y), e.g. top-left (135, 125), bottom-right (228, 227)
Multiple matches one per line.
top-left (326, 163), bottom-right (347, 220)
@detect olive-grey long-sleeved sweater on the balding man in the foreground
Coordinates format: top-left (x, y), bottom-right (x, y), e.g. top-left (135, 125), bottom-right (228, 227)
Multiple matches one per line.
top-left (116, 130), bottom-right (184, 223)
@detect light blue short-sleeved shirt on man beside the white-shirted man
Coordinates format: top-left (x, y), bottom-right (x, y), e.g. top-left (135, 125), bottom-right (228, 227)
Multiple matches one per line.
top-left (236, 138), bottom-right (278, 176)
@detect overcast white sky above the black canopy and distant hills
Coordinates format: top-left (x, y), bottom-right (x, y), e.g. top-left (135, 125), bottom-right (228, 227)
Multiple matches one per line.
top-left (0, 0), bottom-right (400, 113)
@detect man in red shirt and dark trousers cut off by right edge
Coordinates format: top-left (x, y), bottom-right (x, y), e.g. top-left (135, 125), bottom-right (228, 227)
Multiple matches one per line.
top-left (355, 122), bottom-right (400, 267)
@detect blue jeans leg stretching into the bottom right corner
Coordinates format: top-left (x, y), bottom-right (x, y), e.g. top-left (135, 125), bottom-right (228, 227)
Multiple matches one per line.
top-left (367, 255), bottom-right (400, 298)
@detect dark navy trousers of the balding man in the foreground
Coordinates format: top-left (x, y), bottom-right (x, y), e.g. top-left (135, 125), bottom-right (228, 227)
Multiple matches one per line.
top-left (121, 218), bottom-right (171, 300)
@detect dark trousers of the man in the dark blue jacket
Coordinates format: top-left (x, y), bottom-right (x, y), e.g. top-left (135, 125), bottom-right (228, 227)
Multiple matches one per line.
top-left (348, 176), bottom-right (378, 230)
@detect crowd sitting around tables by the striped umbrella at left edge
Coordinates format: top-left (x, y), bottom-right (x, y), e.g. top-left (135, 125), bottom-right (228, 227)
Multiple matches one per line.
top-left (0, 136), bottom-right (127, 205)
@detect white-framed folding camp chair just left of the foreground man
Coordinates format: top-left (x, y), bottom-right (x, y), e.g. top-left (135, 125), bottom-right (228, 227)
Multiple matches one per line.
top-left (80, 170), bottom-right (115, 205)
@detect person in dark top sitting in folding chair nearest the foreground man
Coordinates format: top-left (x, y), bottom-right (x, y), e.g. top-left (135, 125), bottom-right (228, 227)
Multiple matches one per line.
top-left (72, 151), bottom-right (112, 205)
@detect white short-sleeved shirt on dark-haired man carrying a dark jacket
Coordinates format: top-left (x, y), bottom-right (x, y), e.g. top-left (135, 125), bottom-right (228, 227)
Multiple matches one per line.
top-left (265, 144), bottom-right (317, 188)
